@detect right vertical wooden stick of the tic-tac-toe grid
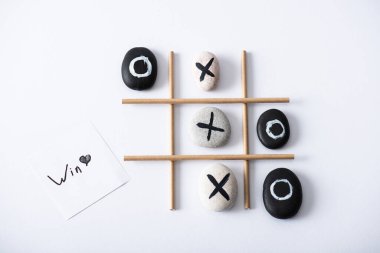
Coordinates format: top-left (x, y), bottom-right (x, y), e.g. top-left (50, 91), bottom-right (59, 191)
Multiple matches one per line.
top-left (241, 50), bottom-right (251, 209)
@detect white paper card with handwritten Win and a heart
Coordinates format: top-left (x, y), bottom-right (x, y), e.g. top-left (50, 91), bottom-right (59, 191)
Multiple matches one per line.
top-left (31, 123), bottom-right (129, 219)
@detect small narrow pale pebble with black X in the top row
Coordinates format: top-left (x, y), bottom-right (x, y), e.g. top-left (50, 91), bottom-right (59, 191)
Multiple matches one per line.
top-left (193, 52), bottom-right (219, 91)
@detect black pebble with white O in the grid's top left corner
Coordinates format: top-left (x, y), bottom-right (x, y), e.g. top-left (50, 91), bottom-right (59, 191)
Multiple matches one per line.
top-left (121, 47), bottom-right (157, 90)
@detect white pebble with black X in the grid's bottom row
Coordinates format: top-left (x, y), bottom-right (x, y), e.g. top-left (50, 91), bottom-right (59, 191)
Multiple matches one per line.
top-left (199, 163), bottom-right (237, 212)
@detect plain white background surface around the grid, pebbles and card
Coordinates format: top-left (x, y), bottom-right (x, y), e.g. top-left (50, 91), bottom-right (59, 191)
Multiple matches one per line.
top-left (0, 0), bottom-right (380, 253)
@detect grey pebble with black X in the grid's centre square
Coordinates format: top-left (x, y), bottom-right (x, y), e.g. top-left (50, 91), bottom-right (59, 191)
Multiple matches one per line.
top-left (190, 107), bottom-right (231, 148)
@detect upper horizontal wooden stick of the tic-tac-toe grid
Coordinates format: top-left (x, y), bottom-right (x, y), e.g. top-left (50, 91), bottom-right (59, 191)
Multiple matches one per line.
top-left (122, 98), bottom-right (289, 104)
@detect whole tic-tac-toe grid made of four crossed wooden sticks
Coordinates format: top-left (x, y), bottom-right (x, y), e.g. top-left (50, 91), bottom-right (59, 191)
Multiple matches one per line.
top-left (122, 50), bottom-right (294, 210)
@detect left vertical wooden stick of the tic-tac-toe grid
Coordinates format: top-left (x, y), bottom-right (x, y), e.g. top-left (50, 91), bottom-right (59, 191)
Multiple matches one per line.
top-left (169, 51), bottom-right (175, 210)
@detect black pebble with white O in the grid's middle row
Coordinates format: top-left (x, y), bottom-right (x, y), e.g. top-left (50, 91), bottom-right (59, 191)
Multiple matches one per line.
top-left (257, 109), bottom-right (290, 149)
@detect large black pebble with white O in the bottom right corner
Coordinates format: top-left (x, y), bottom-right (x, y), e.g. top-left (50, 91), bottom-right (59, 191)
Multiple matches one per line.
top-left (263, 168), bottom-right (302, 219)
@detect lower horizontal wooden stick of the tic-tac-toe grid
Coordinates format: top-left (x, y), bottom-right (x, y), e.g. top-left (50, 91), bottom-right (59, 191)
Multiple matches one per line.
top-left (124, 154), bottom-right (294, 161)
